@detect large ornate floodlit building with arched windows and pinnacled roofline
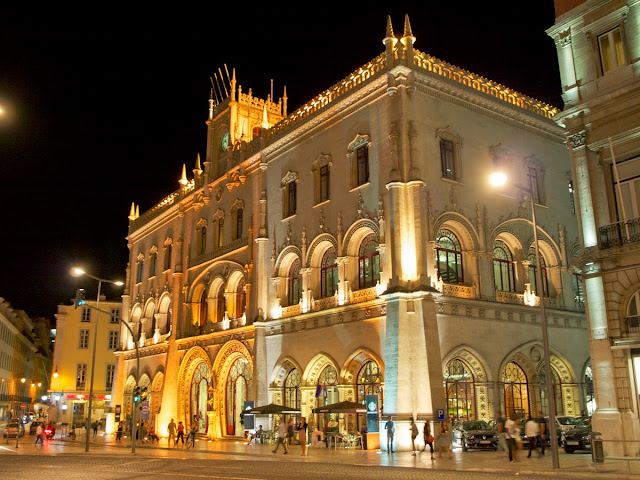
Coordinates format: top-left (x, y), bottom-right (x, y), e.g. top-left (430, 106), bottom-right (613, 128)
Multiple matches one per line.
top-left (114, 18), bottom-right (589, 448)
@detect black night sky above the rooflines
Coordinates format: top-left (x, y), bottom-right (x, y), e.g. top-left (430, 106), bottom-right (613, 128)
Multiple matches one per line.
top-left (0, 0), bottom-right (561, 319)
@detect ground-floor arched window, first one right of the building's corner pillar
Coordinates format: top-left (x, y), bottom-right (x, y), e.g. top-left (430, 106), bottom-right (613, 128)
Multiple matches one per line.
top-left (444, 359), bottom-right (476, 420)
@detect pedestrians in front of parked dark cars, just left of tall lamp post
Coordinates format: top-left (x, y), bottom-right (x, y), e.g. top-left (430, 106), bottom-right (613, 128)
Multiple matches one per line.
top-left (496, 412), bottom-right (549, 462)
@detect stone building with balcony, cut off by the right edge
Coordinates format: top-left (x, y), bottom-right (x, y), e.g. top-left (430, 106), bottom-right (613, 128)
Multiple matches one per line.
top-left (548, 0), bottom-right (640, 454)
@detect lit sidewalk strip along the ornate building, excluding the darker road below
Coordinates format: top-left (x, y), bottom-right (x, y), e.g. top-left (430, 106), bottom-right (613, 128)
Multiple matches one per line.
top-left (0, 434), bottom-right (640, 480)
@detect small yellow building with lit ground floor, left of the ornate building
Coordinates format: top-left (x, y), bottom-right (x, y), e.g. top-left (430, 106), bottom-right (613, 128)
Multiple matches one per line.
top-left (49, 296), bottom-right (122, 424)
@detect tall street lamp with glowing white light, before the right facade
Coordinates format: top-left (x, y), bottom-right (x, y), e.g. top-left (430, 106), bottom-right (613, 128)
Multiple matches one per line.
top-left (489, 172), bottom-right (560, 469)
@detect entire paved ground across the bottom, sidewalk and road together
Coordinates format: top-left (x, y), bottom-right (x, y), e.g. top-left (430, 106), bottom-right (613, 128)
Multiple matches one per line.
top-left (0, 436), bottom-right (640, 480)
